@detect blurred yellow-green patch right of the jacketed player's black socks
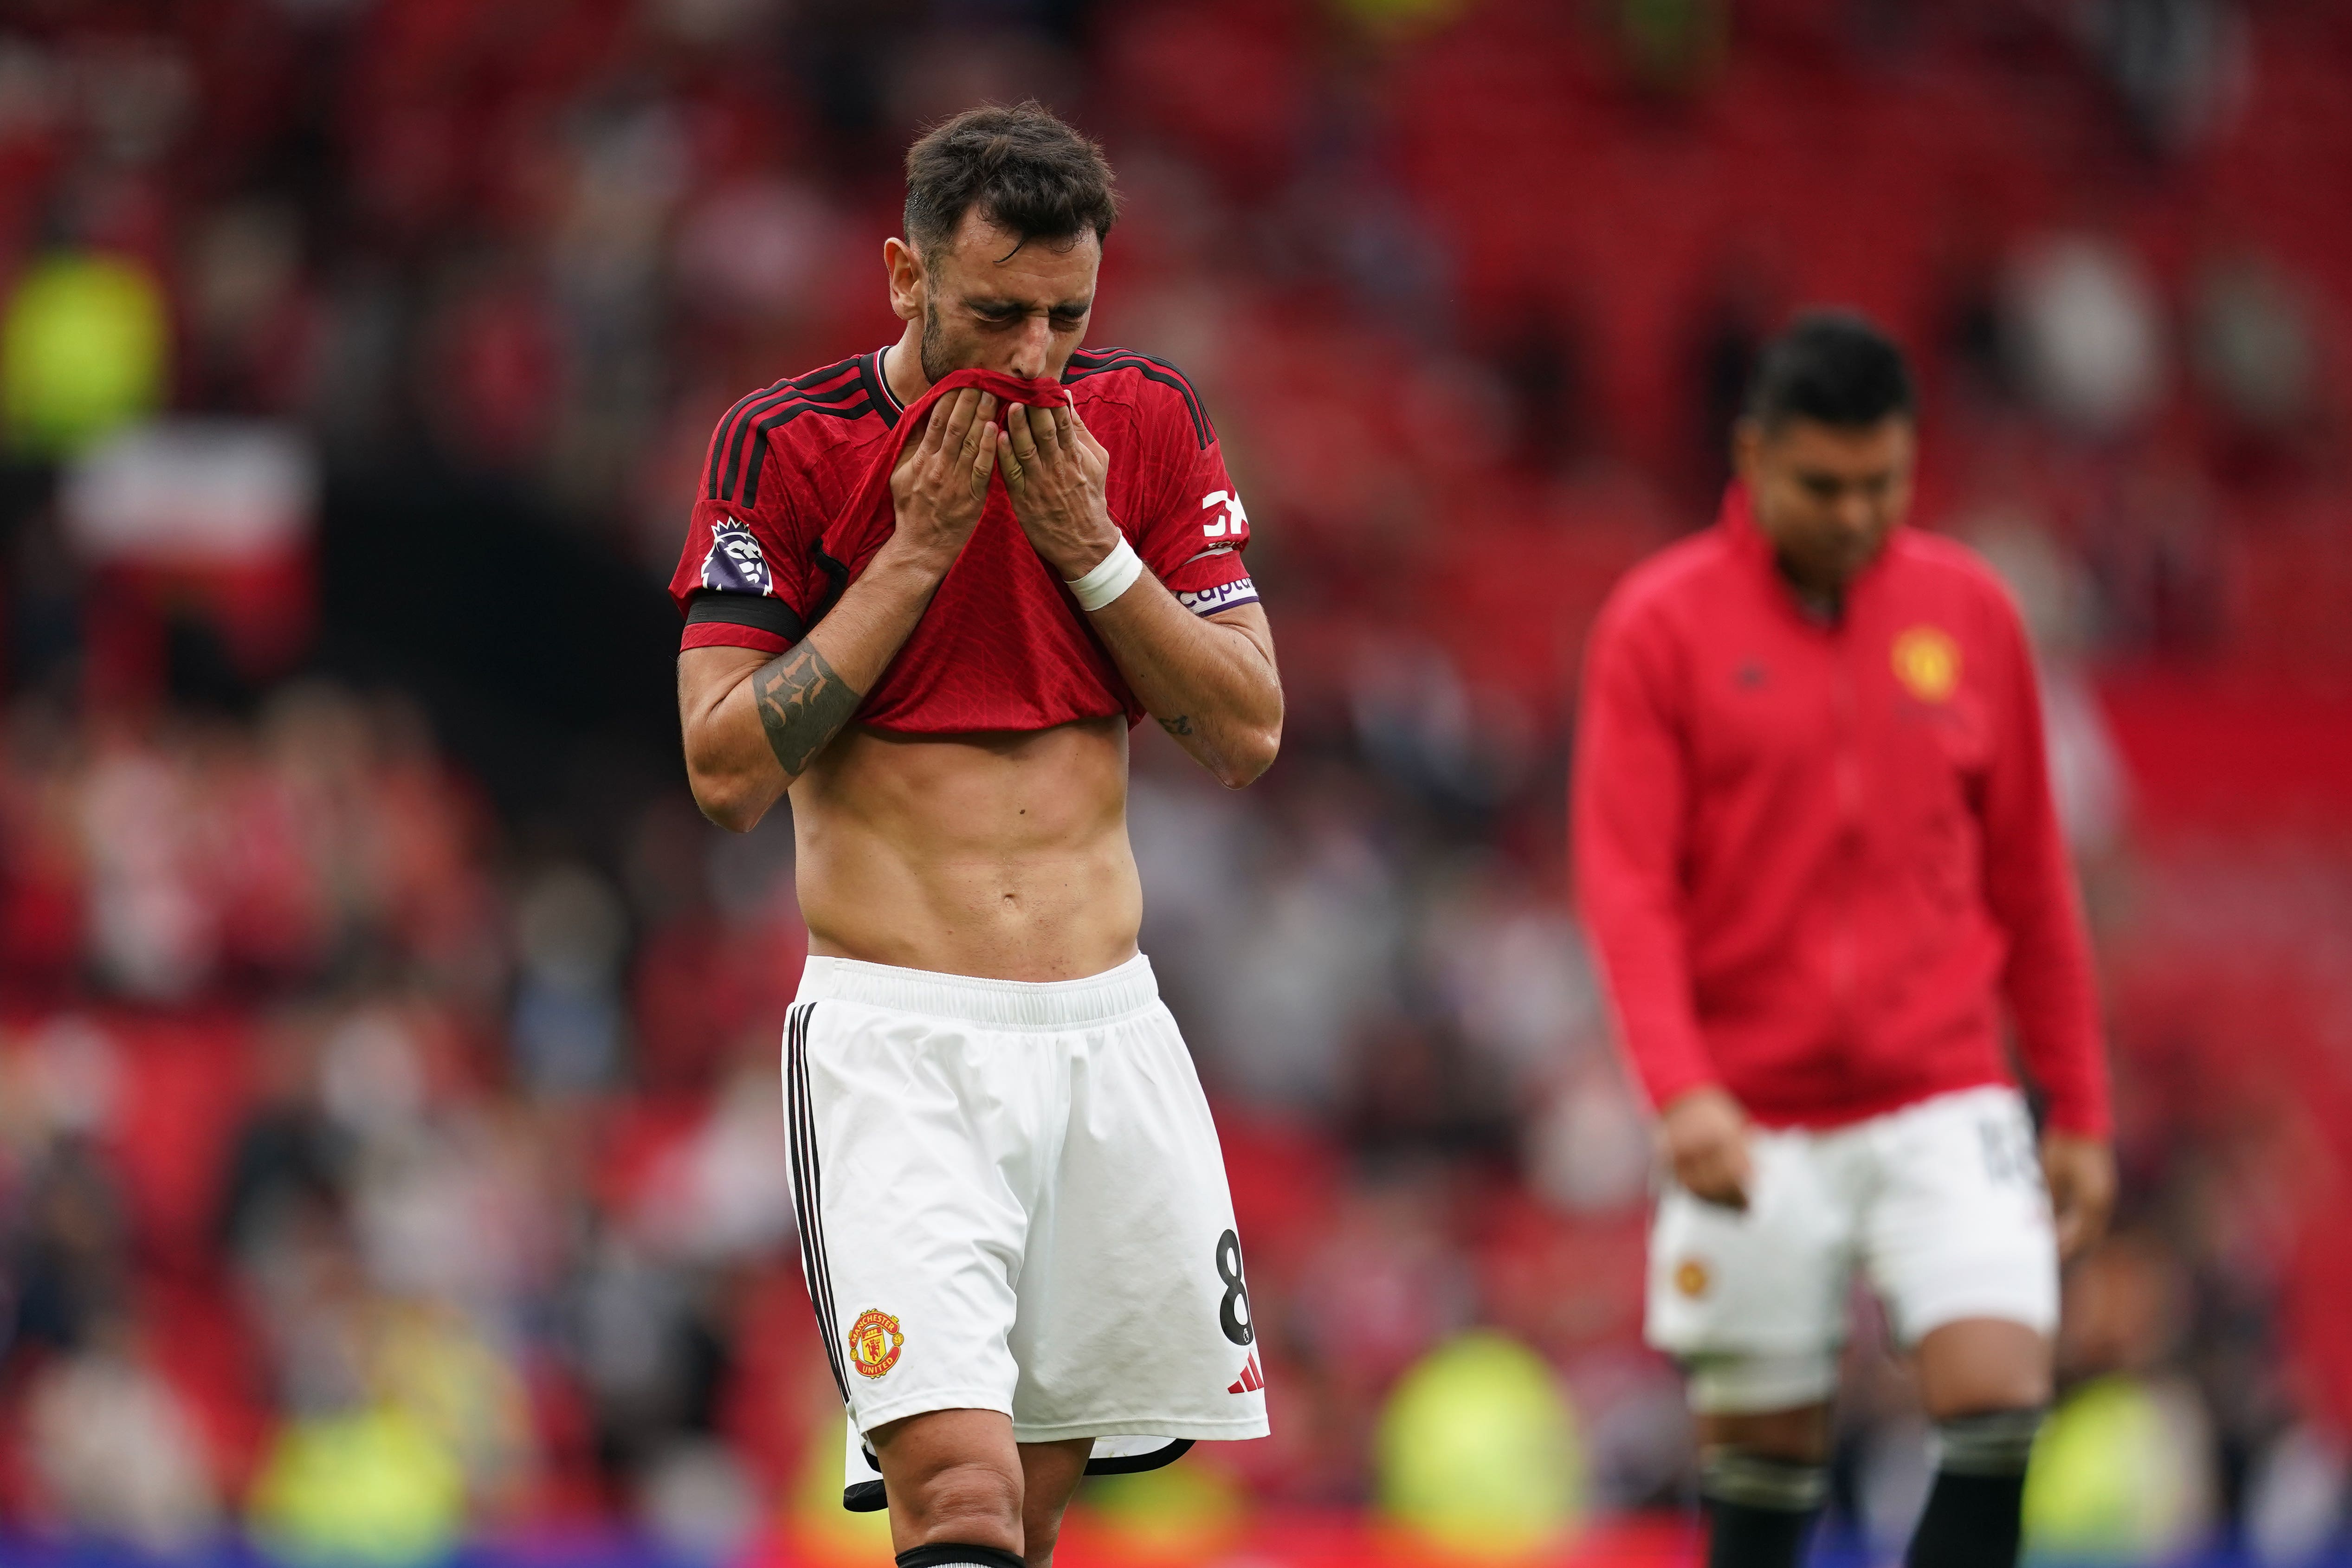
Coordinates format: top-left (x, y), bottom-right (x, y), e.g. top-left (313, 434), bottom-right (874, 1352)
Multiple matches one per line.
top-left (2025, 1375), bottom-right (2202, 1563)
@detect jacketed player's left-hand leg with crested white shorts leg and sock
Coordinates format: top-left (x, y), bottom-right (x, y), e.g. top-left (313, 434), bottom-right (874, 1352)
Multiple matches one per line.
top-left (1649, 1133), bottom-right (1856, 1568)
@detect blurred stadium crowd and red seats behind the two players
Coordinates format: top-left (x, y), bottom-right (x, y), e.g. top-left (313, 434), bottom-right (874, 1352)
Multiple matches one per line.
top-left (0, 0), bottom-right (2352, 1563)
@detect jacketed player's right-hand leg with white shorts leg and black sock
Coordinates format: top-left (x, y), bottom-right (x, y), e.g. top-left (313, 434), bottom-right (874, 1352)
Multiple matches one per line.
top-left (1865, 1089), bottom-right (2058, 1568)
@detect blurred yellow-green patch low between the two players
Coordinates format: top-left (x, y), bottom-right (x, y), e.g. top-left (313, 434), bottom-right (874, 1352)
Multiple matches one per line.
top-left (1378, 1330), bottom-right (1585, 1559)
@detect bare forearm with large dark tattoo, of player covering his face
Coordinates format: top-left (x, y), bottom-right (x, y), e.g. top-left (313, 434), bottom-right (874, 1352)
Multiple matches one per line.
top-left (680, 545), bottom-right (945, 832)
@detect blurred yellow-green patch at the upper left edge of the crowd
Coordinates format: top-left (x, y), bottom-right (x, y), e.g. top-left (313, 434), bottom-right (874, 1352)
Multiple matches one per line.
top-left (0, 252), bottom-right (172, 458)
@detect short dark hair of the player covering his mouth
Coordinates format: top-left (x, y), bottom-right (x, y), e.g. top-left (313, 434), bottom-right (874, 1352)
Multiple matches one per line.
top-left (905, 99), bottom-right (1119, 256)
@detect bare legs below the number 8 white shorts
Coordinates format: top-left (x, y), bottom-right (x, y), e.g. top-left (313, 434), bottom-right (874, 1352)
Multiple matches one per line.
top-left (868, 1411), bottom-right (1094, 1568)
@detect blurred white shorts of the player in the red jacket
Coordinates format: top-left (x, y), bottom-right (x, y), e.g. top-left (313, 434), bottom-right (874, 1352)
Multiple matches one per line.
top-left (1647, 1086), bottom-right (2058, 1413)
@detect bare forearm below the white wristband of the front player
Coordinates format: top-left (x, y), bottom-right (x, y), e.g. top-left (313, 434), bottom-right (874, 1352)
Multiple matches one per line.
top-left (1089, 571), bottom-right (1282, 790)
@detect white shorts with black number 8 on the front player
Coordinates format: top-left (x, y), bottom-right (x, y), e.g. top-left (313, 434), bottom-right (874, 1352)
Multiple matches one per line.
top-left (783, 955), bottom-right (1268, 1509)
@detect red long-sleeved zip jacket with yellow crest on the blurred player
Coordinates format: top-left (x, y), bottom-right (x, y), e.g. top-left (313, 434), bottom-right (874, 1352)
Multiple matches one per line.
top-left (1571, 487), bottom-right (2107, 1136)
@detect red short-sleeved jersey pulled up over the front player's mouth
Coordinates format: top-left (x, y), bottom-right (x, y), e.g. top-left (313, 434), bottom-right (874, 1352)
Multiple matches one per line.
top-left (670, 348), bottom-right (1258, 734)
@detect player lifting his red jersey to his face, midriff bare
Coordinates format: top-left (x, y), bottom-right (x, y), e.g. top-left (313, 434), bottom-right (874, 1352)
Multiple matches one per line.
top-left (672, 103), bottom-right (1282, 1568)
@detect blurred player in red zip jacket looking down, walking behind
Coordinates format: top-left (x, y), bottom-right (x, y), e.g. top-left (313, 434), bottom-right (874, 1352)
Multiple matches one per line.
top-left (1573, 313), bottom-right (2114, 1568)
